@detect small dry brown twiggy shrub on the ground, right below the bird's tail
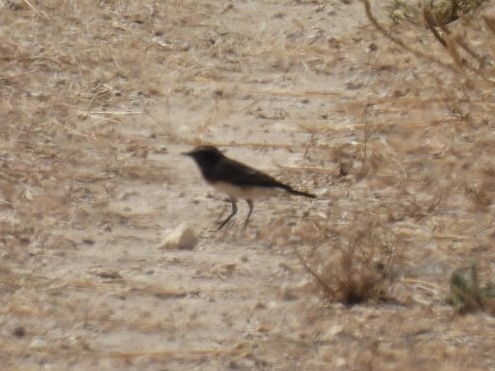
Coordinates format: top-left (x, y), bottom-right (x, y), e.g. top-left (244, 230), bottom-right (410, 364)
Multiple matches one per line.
top-left (293, 201), bottom-right (399, 305)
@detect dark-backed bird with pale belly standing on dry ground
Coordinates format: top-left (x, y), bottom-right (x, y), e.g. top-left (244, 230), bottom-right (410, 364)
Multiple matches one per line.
top-left (182, 145), bottom-right (316, 230)
